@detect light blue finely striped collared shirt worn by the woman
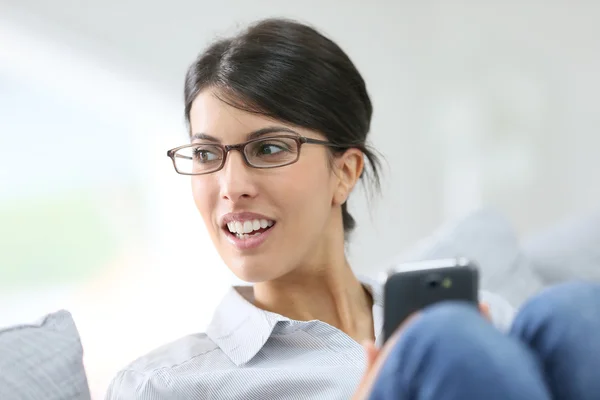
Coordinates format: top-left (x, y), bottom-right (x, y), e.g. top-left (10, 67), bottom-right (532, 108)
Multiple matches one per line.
top-left (106, 281), bottom-right (510, 400)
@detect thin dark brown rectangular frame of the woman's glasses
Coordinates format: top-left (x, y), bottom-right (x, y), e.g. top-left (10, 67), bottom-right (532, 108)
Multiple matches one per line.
top-left (167, 135), bottom-right (347, 176)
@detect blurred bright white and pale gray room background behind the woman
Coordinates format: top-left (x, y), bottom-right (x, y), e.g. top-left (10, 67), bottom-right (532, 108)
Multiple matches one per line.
top-left (0, 0), bottom-right (600, 398)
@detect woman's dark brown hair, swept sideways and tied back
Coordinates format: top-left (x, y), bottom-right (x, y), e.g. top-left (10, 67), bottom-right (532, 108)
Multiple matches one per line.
top-left (184, 19), bottom-right (380, 238)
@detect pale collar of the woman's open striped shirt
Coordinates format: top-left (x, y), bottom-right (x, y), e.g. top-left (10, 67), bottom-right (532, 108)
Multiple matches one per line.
top-left (206, 277), bottom-right (383, 366)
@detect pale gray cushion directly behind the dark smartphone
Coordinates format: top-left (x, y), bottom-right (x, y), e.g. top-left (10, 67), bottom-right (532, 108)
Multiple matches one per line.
top-left (386, 209), bottom-right (543, 307)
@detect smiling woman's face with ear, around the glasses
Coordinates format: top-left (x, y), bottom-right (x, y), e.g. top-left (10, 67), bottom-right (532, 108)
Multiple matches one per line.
top-left (190, 89), bottom-right (362, 282)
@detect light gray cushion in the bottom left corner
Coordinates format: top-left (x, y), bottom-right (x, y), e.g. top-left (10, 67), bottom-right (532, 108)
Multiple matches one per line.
top-left (0, 311), bottom-right (90, 400)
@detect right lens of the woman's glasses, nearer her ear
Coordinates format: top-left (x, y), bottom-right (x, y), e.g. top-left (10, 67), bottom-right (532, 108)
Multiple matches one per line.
top-left (244, 137), bottom-right (298, 168)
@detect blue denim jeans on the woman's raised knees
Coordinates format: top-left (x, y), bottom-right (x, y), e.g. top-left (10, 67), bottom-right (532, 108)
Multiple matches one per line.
top-left (370, 282), bottom-right (600, 400)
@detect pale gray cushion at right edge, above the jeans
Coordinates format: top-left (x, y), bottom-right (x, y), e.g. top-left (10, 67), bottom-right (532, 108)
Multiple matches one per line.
top-left (523, 213), bottom-right (600, 284)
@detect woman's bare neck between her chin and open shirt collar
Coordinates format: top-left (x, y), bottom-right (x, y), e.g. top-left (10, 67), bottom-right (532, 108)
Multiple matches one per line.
top-left (254, 243), bottom-right (374, 342)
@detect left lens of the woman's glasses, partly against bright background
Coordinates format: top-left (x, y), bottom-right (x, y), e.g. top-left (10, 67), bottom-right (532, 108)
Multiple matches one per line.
top-left (174, 144), bottom-right (223, 174)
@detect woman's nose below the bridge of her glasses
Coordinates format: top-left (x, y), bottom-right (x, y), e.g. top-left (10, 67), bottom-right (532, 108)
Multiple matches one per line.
top-left (218, 151), bottom-right (258, 202)
